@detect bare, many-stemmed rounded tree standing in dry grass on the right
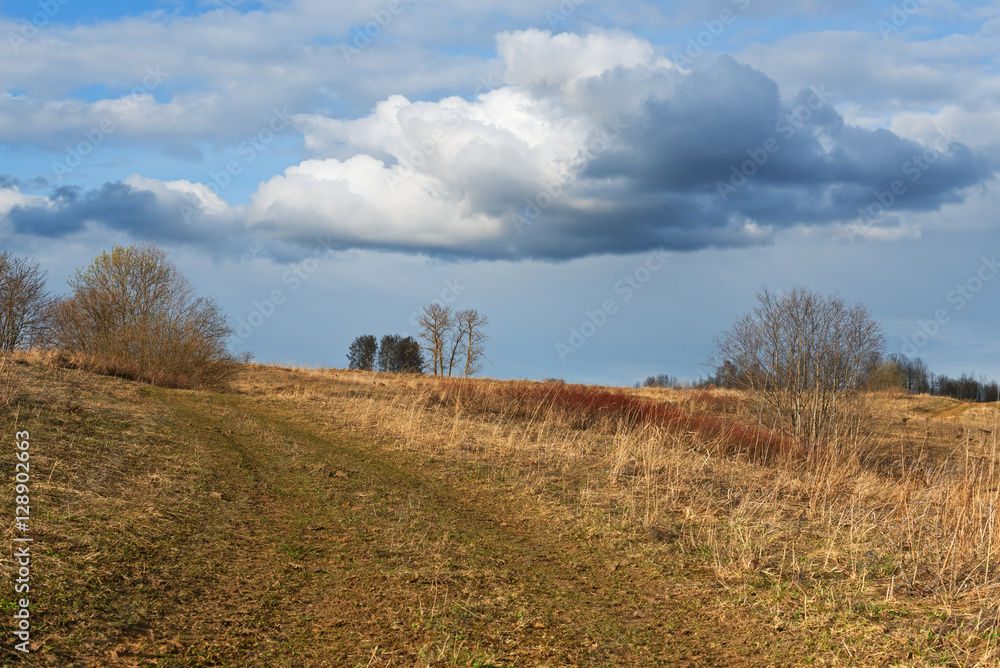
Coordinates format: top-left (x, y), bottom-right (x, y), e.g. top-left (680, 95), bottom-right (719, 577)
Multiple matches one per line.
top-left (712, 287), bottom-right (885, 447)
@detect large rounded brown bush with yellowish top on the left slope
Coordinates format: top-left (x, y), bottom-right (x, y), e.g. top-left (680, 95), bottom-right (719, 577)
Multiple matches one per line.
top-left (52, 244), bottom-right (235, 388)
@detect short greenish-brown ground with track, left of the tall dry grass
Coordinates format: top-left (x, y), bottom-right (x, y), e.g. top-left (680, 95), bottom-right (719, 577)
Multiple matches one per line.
top-left (4, 371), bottom-right (803, 666)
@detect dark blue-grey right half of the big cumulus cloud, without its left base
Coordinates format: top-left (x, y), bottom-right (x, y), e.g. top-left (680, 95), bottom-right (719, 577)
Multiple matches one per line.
top-left (585, 57), bottom-right (994, 250)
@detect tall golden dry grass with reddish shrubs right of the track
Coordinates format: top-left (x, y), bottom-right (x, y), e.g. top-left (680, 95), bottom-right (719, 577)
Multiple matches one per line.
top-left (234, 367), bottom-right (1000, 665)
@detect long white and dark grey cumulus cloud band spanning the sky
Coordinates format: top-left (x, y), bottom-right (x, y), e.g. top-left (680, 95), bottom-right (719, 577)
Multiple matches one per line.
top-left (7, 30), bottom-right (993, 258)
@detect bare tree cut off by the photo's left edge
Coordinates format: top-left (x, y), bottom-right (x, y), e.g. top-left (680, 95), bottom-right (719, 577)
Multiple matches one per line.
top-left (0, 251), bottom-right (54, 351)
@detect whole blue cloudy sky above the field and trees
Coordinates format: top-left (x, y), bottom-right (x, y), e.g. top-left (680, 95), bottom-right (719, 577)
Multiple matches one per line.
top-left (0, 0), bottom-right (1000, 385)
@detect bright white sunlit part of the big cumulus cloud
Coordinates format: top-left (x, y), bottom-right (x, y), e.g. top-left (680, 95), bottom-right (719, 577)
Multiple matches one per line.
top-left (243, 30), bottom-right (678, 249)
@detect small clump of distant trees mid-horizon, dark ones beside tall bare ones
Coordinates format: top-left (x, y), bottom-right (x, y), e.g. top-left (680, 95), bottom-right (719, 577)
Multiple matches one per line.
top-left (347, 303), bottom-right (490, 377)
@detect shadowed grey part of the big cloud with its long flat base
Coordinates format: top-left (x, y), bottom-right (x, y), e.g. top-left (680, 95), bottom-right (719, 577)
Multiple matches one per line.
top-left (282, 57), bottom-right (995, 260)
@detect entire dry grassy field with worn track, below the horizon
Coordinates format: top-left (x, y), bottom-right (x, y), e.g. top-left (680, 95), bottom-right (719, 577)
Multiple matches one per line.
top-left (0, 354), bottom-right (1000, 667)
